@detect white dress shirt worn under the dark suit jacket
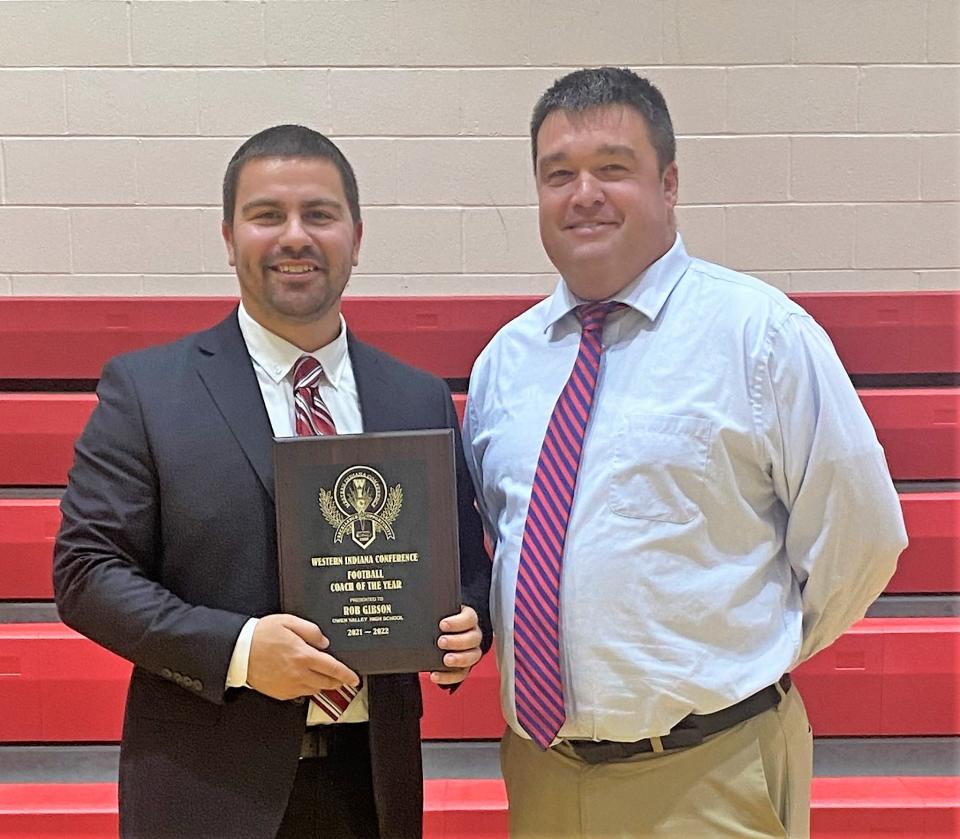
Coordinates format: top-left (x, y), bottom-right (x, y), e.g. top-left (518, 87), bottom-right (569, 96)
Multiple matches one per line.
top-left (227, 303), bottom-right (368, 725)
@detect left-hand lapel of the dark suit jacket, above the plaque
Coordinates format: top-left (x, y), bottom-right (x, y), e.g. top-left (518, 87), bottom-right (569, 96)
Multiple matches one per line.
top-left (197, 309), bottom-right (274, 498)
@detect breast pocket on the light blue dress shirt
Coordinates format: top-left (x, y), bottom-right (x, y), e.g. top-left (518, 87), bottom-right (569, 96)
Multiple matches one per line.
top-left (608, 414), bottom-right (712, 524)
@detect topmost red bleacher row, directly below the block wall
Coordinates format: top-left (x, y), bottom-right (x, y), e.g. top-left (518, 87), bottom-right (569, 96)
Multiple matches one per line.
top-left (0, 291), bottom-right (960, 379)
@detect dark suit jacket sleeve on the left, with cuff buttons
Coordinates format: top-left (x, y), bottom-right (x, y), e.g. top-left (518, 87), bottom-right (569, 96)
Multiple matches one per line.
top-left (53, 357), bottom-right (249, 702)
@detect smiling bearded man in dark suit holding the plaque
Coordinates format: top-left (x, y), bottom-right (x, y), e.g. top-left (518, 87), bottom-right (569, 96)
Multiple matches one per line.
top-left (54, 126), bottom-right (490, 839)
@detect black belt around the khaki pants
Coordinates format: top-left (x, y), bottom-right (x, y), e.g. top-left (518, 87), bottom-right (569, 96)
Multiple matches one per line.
top-left (564, 673), bottom-right (791, 763)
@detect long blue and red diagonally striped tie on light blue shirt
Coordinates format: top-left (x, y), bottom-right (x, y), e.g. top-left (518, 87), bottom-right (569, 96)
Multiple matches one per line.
top-left (513, 301), bottom-right (624, 749)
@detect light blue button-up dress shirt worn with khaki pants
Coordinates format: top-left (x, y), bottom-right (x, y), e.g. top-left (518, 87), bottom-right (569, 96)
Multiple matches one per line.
top-left (464, 236), bottom-right (906, 741)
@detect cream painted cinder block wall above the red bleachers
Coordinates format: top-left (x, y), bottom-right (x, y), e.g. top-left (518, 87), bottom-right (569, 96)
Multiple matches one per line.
top-left (0, 0), bottom-right (960, 295)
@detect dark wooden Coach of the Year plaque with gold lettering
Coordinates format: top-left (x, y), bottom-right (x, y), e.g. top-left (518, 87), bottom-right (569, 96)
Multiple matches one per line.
top-left (273, 429), bottom-right (460, 674)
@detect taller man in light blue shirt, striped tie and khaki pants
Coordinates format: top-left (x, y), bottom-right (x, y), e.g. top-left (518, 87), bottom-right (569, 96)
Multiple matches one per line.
top-left (464, 68), bottom-right (906, 837)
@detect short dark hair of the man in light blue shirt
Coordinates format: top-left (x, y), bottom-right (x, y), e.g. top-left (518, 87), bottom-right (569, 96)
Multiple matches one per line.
top-left (530, 67), bottom-right (677, 173)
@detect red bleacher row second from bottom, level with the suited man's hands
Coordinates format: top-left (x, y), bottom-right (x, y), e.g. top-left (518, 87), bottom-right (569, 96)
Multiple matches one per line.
top-left (0, 618), bottom-right (960, 742)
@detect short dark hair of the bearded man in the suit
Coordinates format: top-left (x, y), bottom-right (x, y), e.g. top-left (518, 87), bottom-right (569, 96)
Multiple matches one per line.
top-left (223, 125), bottom-right (360, 224)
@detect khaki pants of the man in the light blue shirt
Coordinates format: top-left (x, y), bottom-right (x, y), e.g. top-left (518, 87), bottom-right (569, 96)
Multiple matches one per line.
top-left (500, 688), bottom-right (813, 839)
